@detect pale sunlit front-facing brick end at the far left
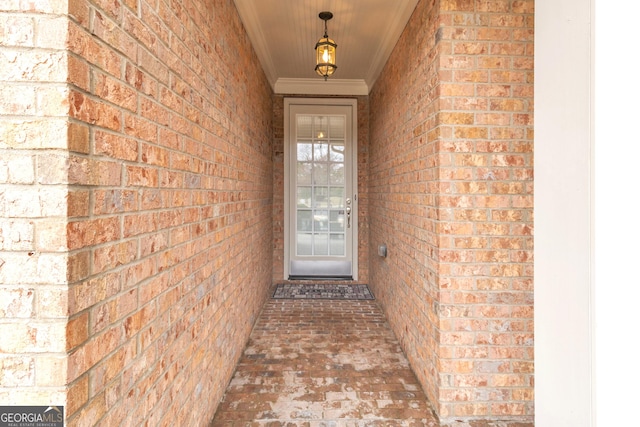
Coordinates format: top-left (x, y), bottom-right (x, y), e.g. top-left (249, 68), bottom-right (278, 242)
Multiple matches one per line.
top-left (0, 1), bottom-right (71, 405)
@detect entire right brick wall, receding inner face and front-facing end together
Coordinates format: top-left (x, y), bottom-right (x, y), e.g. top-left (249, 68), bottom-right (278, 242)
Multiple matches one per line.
top-left (369, 0), bottom-right (534, 423)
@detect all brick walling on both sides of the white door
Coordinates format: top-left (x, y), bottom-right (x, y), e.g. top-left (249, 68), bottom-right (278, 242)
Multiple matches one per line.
top-left (5, 0), bottom-right (533, 426)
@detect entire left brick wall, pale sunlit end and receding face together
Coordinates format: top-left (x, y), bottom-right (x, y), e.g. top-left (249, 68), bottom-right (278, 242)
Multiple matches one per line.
top-left (0, 0), bottom-right (273, 426)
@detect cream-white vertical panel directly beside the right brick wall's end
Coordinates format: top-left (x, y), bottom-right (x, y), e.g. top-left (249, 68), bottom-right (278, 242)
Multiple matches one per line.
top-left (534, 0), bottom-right (593, 427)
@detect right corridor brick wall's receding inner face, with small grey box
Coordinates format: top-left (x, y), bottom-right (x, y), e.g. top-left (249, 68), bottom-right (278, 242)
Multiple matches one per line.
top-left (369, 1), bottom-right (438, 412)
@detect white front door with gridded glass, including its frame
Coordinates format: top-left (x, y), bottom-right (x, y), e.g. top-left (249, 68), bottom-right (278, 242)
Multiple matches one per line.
top-left (285, 98), bottom-right (358, 279)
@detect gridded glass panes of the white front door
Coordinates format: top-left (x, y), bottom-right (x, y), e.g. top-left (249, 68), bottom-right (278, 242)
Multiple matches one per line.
top-left (295, 114), bottom-right (346, 257)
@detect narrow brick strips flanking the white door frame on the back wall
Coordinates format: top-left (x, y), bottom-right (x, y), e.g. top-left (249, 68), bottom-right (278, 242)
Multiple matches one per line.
top-left (273, 95), bottom-right (369, 283)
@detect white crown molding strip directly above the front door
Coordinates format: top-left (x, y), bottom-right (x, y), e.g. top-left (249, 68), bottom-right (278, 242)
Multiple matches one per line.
top-left (273, 78), bottom-right (369, 95)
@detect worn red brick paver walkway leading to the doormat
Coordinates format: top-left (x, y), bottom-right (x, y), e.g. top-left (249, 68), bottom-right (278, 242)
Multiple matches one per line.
top-left (211, 300), bottom-right (438, 427)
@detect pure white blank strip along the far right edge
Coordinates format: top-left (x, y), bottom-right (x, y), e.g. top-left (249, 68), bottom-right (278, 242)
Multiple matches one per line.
top-left (593, 0), bottom-right (640, 427)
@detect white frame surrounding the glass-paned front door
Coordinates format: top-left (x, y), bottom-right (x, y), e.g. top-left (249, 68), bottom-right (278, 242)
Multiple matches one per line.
top-left (283, 97), bottom-right (359, 280)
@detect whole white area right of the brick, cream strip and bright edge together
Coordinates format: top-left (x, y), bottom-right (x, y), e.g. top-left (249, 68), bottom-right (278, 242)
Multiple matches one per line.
top-left (534, 0), bottom-right (640, 427)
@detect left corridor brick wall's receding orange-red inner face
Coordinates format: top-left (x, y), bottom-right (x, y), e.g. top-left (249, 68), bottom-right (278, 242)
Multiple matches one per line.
top-left (67, 0), bottom-right (272, 425)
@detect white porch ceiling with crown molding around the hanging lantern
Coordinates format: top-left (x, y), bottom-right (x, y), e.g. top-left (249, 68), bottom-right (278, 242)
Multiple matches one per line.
top-left (234, 0), bottom-right (418, 95)
